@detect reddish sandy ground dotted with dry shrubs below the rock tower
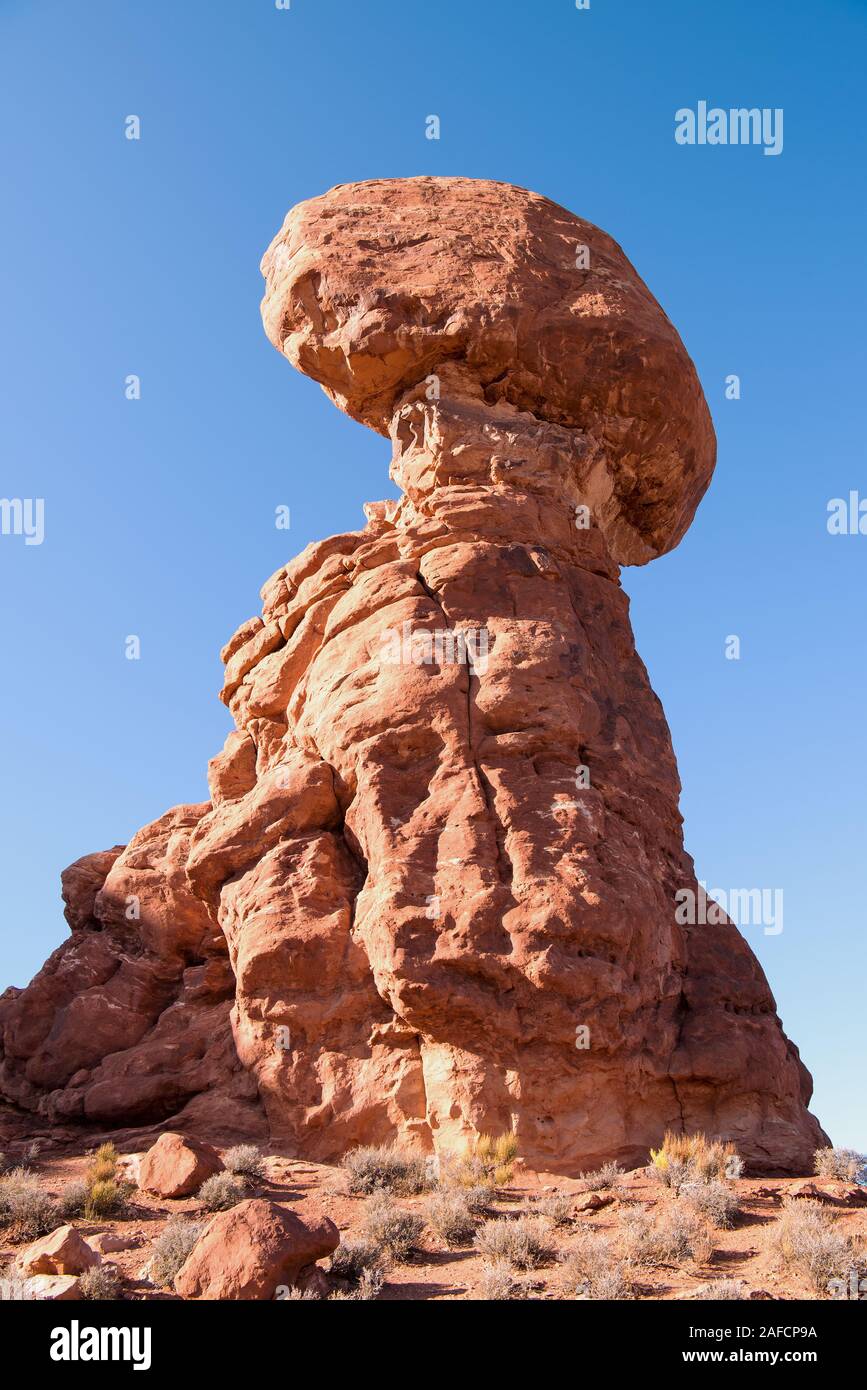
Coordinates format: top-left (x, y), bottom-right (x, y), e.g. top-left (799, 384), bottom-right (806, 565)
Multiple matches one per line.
top-left (0, 1134), bottom-right (867, 1302)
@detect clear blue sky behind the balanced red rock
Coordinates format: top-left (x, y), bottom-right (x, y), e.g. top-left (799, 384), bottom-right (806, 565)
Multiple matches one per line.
top-left (0, 0), bottom-right (867, 1148)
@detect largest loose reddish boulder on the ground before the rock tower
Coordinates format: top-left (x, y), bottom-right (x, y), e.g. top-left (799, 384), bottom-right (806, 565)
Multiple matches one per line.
top-left (175, 1197), bottom-right (340, 1300)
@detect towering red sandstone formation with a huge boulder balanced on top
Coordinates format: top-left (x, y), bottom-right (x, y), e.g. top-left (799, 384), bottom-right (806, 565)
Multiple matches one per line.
top-left (0, 178), bottom-right (824, 1172)
